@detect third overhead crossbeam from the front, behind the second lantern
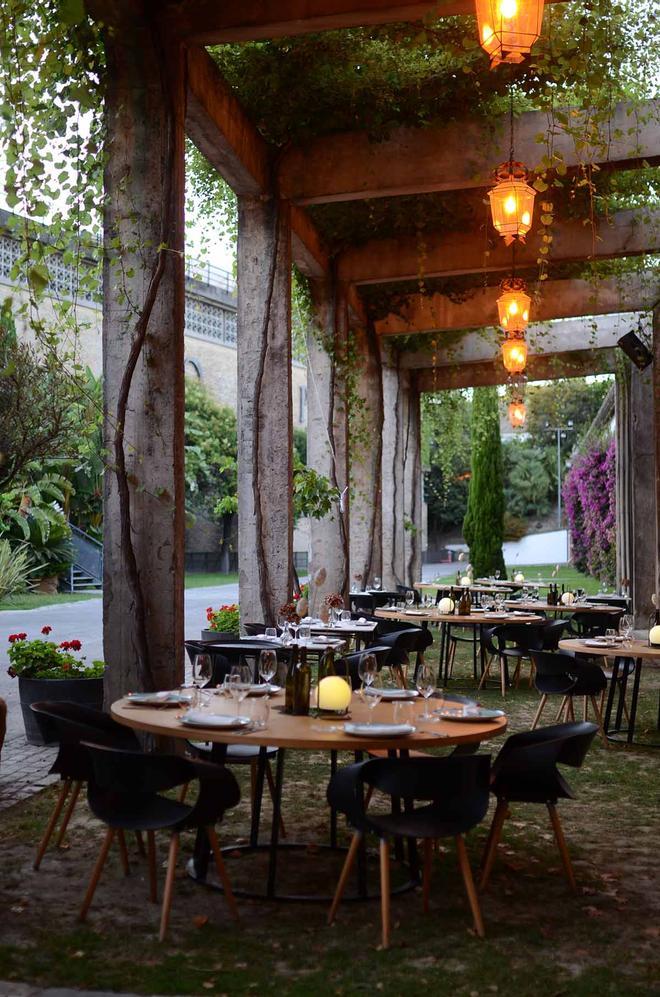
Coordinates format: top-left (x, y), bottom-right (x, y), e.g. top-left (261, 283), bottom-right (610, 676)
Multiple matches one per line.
top-left (338, 210), bottom-right (660, 284)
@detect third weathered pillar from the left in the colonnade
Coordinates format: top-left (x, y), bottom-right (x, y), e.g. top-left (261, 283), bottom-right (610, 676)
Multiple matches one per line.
top-left (307, 277), bottom-right (350, 614)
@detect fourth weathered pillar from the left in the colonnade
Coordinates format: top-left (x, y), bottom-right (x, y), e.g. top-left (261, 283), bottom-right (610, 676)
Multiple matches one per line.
top-left (351, 322), bottom-right (383, 586)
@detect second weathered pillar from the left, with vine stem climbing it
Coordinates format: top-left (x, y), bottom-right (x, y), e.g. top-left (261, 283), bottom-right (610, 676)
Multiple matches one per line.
top-left (237, 197), bottom-right (293, 624)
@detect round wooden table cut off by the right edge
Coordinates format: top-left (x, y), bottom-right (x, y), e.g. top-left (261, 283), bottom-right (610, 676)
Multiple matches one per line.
top-left (559, 637), bottom-right (660, 748)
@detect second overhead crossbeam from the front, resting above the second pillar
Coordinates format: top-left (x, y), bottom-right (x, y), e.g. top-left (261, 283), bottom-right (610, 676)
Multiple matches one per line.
top-left (279, 101), bottom-right (660, 204)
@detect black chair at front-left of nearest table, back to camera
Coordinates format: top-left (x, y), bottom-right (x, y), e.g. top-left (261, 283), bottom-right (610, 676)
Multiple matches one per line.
top-left (79, 744), bottom-right (241, 942)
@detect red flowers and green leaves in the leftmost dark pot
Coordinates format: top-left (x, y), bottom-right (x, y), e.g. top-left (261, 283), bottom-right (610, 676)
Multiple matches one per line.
top-left (7, 626), bottom-right (105, 679)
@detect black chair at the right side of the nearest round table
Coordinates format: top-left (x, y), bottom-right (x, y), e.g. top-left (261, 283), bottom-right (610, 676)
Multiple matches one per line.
top-left (480, 723), bottom-right (598, 892)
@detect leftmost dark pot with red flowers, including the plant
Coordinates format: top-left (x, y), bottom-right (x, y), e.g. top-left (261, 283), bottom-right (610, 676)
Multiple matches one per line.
top-left (7, 626), bottom-right (105, 744)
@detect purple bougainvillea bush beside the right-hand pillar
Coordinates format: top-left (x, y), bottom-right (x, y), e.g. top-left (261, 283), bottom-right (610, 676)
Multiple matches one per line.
top-left (563, 440), bottom-right (616, 584)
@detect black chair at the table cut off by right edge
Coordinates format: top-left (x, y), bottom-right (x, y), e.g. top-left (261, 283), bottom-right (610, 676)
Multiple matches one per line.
top-left (531, 651), bottom-right (608, 745)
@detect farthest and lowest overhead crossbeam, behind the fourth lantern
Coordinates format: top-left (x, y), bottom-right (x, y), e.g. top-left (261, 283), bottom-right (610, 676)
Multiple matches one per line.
top-left (417, 349), bottom-right (616, 391)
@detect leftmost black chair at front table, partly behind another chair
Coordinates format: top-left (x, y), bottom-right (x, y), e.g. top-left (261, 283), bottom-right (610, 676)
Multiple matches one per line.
top-left (31, 702), bottom-right (141, 873)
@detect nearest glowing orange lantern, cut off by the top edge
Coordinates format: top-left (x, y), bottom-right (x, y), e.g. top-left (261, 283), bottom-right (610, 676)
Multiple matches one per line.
top-left (477, 0), bottom-right (543, 69)
